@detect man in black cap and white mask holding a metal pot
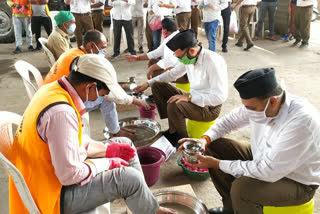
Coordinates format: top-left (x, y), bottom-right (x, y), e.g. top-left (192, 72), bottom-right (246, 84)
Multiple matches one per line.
top-left (179, 68), bottom-right (320, 214)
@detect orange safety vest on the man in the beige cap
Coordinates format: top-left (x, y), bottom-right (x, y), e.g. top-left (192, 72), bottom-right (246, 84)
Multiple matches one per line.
top-left (9, 81), bottom-right (82, 214)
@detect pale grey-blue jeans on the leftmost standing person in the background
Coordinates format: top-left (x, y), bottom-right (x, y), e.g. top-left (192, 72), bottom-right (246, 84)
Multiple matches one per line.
top-left (12, 16), bottom-right (32, 48)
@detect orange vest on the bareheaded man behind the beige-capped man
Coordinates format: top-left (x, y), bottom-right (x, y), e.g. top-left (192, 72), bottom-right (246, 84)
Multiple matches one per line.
top-left (43, 48), bottom-right (87, 84)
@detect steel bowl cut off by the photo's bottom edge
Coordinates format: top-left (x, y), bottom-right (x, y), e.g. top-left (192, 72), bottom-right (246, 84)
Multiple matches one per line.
top-left (153, 190), bottom-right (209, 214)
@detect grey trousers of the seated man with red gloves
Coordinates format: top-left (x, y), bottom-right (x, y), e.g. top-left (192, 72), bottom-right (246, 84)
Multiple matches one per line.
top-left (61, 137), bottom-right (159, 214)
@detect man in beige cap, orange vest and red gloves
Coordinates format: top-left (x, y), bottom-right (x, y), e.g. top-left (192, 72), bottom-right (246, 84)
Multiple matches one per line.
top-left (9, 54), bottom-right (175, 214)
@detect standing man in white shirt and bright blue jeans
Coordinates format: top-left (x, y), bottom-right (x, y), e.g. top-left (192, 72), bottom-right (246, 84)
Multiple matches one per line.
top-left (200, 0), bottom-right (228, 52)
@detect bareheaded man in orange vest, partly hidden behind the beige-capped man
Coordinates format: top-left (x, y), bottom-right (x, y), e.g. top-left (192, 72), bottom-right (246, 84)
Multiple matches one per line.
top-left (43, 30), bottom-right (148, 140)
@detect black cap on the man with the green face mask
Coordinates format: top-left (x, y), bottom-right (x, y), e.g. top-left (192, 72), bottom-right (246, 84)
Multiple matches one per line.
top-left (167, 29), bottom-right (197, 51)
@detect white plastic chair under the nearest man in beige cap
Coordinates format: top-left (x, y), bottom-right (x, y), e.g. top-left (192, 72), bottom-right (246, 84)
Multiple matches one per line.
top-left (0, 111), bottom-right (40, 214)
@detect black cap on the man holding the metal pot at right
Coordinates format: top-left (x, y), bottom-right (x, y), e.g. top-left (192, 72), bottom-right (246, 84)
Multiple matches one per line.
top-left (233, 68), bottom-right (278, 99)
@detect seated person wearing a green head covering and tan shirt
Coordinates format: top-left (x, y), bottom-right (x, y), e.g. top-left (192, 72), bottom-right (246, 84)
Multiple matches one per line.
top-left (47, 11), bottom-right (76, 60)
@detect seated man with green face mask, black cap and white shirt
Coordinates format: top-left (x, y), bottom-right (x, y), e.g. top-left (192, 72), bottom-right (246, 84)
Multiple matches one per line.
top-left (134, 30), bottom-right (228, 146)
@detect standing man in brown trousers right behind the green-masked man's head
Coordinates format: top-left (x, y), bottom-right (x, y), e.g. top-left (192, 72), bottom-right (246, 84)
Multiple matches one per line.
top-left (174, 0), bottom-right (191, 31)
